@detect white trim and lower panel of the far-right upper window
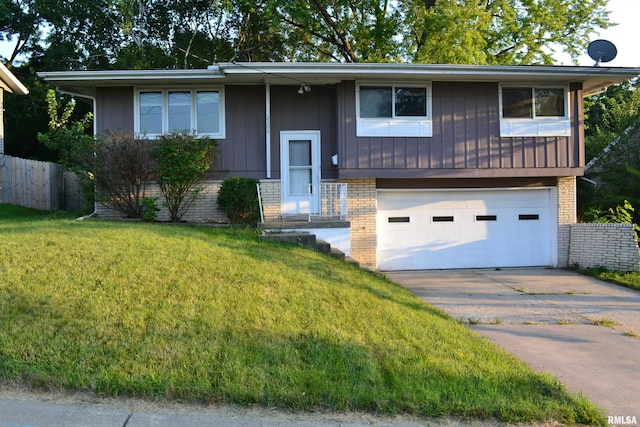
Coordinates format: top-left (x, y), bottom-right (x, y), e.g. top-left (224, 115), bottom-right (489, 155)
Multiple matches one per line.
top-left (498, 83), bottom-right (571, 137)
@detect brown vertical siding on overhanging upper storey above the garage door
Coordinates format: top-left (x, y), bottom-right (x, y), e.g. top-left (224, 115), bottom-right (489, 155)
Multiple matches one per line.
top-left (338, 81), bottom-right (584, 178)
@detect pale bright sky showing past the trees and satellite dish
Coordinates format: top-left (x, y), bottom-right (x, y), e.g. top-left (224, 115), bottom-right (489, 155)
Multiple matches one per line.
top-left (0, 0), bottom-right (640, 67)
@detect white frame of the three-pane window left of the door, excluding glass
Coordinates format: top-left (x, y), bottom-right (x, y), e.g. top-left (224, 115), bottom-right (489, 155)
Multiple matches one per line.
top-left (133, 86), bottom-right (226, 139)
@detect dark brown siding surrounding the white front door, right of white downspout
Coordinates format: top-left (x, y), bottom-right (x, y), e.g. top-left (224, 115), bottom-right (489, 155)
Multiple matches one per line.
top-left (270, 86), bottom-right (338, 179)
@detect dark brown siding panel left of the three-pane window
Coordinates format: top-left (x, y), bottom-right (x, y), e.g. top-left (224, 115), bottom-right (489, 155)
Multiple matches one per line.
top-left (95, 87), bottom-right (133, 134)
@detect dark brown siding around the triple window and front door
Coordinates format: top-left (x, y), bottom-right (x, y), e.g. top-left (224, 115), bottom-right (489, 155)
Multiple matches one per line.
top-left (96, 85), bottom-right (337, 180)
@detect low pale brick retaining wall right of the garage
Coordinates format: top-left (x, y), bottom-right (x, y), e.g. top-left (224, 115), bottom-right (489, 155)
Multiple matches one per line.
top-left (569, 224), bottom-right (640, 271)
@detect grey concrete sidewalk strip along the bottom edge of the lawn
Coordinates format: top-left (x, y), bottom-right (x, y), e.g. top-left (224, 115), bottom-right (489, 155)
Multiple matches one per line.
top-left (0, 389), bottom-right (503, 427)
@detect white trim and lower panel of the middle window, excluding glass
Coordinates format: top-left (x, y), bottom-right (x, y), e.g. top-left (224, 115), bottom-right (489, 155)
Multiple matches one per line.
top-left (356, 82), bottom-right (433, 137)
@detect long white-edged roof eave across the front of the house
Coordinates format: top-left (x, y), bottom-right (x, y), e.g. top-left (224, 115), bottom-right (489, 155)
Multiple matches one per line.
top-left (38, 62), bottom-right (640, 96)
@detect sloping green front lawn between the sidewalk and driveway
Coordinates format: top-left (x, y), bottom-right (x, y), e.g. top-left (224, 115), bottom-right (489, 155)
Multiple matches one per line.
top-left (0, 205), bottom-right (604, 425)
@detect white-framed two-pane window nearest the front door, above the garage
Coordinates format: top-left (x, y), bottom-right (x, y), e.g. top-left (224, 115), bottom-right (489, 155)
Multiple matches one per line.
top-left (356, 83), bottom-right (433, 136)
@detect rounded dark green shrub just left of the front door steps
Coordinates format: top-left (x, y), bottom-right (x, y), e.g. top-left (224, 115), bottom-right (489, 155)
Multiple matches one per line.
top-left (218, 177), bottom-right (260, 225)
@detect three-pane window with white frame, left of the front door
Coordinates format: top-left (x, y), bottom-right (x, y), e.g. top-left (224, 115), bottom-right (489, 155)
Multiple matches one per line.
top-left (135, 88), bottom-right (225, 138)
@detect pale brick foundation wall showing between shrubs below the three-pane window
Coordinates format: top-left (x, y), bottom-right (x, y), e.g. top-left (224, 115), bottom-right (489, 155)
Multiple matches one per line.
top-left (96, 181), bottom-right (228, 223)
